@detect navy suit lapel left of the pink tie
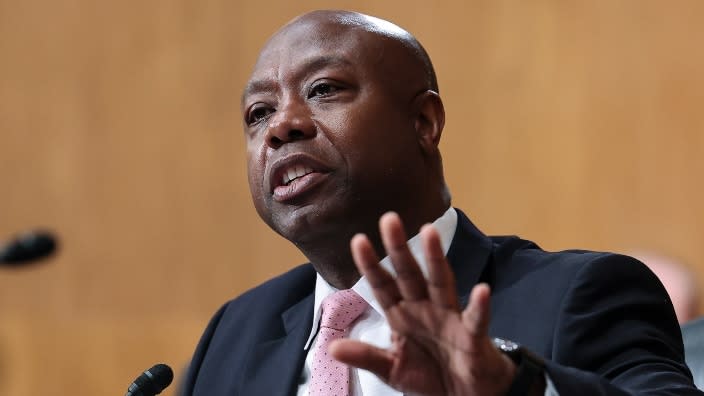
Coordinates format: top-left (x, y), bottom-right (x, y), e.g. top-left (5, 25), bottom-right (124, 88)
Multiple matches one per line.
top-left (242, 293), bottom-right (314, 396)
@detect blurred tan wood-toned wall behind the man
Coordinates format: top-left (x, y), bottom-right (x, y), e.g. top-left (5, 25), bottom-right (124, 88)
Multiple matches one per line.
top-left (0, 0), bottom-right (704, 396)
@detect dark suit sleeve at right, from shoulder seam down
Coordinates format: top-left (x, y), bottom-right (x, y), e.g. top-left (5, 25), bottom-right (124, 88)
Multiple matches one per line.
top-left (546, 255), bottom-right (704, 396)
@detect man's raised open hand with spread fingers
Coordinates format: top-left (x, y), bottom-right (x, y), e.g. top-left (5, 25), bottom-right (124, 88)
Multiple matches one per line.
top-left (330, 213), bottom-right (516, 395)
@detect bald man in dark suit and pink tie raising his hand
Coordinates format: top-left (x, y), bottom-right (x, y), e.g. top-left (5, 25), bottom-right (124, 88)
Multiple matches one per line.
top-left (180, 11), bottom-right (699, 396)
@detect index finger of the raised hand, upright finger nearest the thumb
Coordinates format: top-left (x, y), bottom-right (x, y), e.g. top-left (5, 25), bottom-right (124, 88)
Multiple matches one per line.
top-left (350, 234), bottom-right (401, 310)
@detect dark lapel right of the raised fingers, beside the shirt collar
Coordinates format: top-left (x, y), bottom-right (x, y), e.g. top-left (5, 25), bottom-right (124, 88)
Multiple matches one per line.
top-left (447, 209), bottom-right (492, 308)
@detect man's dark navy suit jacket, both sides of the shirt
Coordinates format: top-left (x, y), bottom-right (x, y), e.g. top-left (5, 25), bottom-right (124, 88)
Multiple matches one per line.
top-left (184, 211), bottom-right (700, 396)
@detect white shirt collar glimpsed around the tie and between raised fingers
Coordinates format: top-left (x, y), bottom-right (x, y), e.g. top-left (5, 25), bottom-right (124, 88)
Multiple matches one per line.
top-left (304, 207), bottom-right (457, 349)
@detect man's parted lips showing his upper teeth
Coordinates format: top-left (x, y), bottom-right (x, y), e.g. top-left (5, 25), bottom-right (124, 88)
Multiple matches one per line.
top-left (269, 153), bottom-right (329, 202)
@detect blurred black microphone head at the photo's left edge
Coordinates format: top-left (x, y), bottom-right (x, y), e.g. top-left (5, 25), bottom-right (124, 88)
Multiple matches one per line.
top-left (0, 230), bottom-right (58, 266)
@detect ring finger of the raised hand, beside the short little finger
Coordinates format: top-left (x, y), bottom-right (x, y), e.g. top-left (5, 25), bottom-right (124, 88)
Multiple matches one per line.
top-left (420, 224), bottom-right (459, 311)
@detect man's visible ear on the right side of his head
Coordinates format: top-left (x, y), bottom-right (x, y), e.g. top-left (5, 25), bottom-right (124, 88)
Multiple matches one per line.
top-left (414, 90), bottom-right (445, 154)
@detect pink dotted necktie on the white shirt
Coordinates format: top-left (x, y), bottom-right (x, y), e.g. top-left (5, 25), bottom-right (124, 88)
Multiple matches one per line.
top-left (308, 289), bottom-right (367, 396)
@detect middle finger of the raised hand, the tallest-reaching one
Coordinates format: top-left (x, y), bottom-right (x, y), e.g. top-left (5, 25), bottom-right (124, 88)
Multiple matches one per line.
top-left (379, 212), bottom-right (428, 301)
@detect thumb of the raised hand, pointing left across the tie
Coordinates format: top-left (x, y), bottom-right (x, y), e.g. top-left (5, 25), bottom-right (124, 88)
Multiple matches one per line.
top-left (328, 339), bottom-right (393, 382)
